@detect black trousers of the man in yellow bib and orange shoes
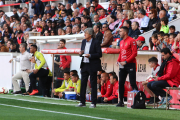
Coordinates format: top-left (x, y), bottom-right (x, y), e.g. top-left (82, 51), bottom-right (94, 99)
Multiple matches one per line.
top-left (29, 68), bottom-right (49, 96)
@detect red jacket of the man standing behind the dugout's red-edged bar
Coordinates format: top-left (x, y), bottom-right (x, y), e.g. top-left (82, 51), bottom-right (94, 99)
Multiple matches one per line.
top-left (59, 47), bottom-right (71, 69)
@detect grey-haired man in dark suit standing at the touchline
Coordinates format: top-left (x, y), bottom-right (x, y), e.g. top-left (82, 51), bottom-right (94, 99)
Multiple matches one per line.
top-left (77, 28), bottom-right (102, 108)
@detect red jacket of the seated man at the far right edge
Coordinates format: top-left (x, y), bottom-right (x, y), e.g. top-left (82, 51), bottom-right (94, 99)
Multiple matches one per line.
top-left (158, 58), bottom-right (180, 87)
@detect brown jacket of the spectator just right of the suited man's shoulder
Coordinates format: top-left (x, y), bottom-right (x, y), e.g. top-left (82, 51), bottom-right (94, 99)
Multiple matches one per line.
top-left (101, 30), bottom-right (113, 47)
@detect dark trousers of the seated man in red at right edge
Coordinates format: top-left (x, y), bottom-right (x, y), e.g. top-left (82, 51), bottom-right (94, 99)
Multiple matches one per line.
top-left (147, 80), bottom-right (170, 97)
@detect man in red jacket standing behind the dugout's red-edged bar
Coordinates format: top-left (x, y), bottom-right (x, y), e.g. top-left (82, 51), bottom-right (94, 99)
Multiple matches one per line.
top-left (54, 39), bottom-right (71, 88)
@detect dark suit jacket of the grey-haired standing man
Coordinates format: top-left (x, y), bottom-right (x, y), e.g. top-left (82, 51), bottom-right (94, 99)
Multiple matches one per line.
top-left (80, 38), bottom-right (102, 72)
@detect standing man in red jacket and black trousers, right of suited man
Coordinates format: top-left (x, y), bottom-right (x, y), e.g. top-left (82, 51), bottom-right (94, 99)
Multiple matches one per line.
top-left (116, 27), bottom-right (138, 107)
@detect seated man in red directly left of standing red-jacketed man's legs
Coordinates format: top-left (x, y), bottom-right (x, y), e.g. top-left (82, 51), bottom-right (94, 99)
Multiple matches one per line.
top-left (104, 74), bottom-right (119, 103)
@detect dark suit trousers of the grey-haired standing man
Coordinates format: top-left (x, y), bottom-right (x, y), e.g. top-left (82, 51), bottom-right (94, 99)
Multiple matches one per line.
top-left (80, 63), bottom-right (97, 104)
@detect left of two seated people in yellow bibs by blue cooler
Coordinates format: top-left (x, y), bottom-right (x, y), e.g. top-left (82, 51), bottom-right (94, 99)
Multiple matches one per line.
top-left (52, 72), bottom-right (73, 96)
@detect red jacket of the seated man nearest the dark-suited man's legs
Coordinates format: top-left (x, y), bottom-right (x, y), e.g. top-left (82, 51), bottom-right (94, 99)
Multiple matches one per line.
top-left (101, 80), bottom-right (113, 97)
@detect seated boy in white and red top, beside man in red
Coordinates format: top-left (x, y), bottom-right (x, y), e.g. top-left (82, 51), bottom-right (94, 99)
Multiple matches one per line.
top-left (142, 57), bottom-right (160, 104)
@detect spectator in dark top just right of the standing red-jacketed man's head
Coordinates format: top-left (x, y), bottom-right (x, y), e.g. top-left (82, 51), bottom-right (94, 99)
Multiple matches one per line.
top-left (130, 22), bottom-right (141, 38)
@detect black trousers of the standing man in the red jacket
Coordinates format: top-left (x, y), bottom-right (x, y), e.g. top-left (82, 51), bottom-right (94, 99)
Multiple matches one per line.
top-left (119, 63), bottom-right (138, 102)
